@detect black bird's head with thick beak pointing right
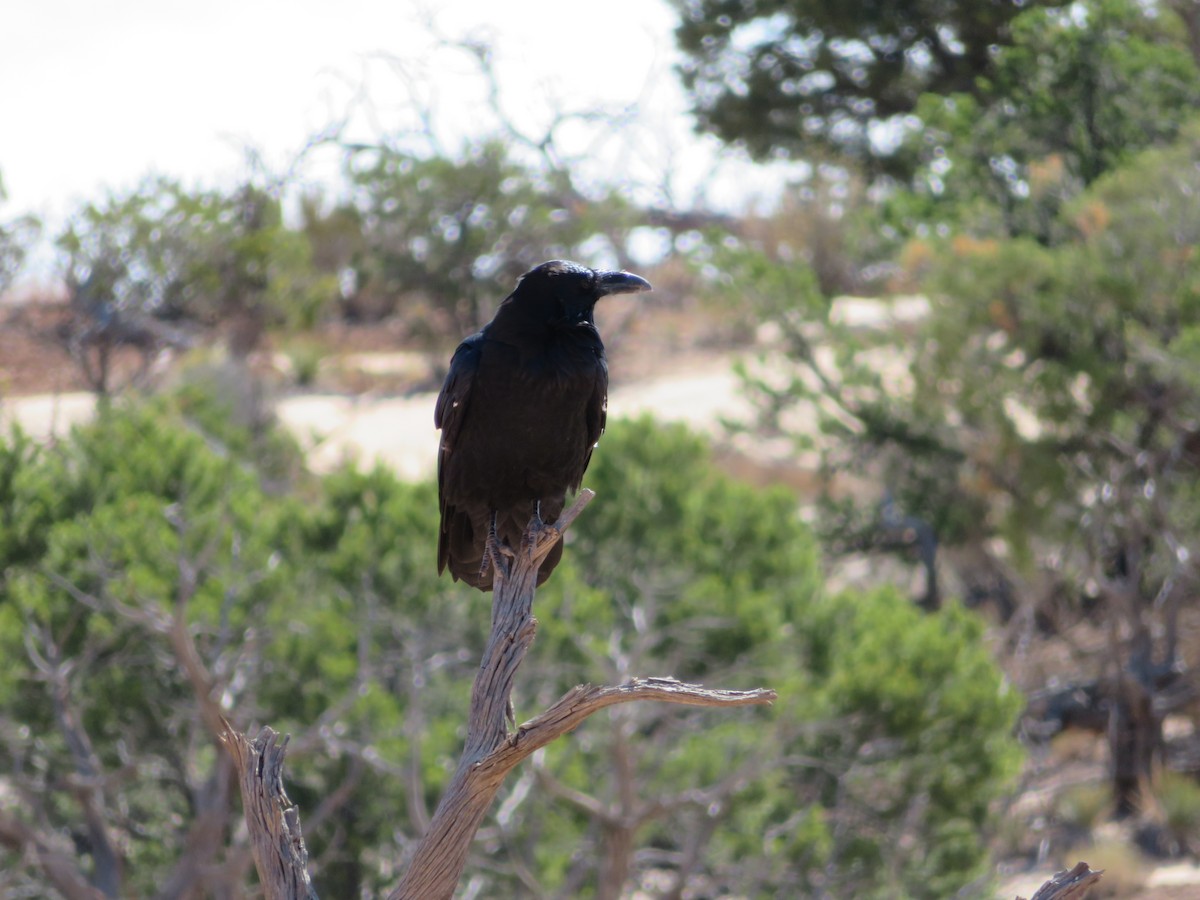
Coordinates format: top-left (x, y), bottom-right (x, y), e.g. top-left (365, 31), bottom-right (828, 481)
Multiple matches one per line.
top-left (509, 259), bottom-right (650, 325)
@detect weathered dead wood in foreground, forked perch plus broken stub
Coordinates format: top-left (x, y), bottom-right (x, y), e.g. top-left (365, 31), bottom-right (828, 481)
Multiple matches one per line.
top-left (222, 490), bottom-right (775, 900)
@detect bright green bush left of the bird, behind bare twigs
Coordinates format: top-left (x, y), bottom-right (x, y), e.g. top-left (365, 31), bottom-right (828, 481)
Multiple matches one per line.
top-left (0, 405), bottom-right (436, 895)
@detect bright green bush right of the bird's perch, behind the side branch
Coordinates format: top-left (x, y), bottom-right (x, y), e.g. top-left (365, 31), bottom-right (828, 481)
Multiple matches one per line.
top-left (514, 420), bottom-right (1021, 896)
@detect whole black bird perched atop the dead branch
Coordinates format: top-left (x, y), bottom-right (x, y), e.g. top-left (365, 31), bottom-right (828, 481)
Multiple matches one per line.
top-left (433, 259), bottom-right (650, 590)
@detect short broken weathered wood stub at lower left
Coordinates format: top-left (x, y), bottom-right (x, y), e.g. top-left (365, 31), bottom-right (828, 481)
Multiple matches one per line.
top-left (221, 720), bottom-right (317, 900)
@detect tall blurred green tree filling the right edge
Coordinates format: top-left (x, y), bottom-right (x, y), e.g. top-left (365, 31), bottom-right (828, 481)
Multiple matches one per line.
top-left (738, 1), bottom-right (1200, 815)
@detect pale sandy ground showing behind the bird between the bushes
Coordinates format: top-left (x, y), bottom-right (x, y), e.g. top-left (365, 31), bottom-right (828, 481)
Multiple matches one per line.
top-left (0, 298), bottom-right (928, 480)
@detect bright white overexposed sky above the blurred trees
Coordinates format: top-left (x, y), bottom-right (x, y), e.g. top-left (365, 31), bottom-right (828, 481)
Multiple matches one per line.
top-left (0, 0), bottom-right (801, 250)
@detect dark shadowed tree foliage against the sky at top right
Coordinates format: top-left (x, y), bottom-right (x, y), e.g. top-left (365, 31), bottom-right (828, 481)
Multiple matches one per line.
top-left (676, 0), bottom-right (1041, 173)
